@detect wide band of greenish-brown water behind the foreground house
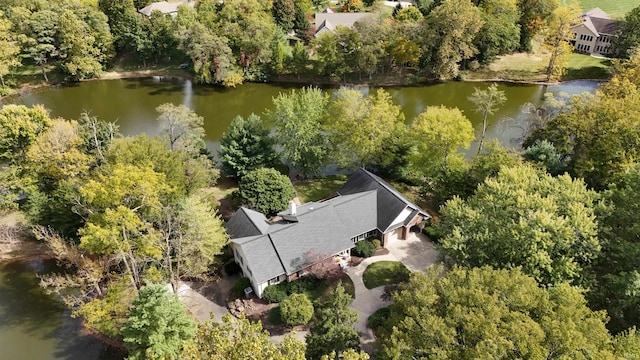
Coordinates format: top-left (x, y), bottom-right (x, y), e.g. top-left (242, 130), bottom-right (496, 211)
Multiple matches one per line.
top-left (5, 77), bottom-right (598, 153)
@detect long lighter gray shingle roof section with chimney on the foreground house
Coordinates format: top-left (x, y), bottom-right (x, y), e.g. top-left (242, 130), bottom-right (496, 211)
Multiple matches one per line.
top-left (227, 191), bottom-right (377, 282)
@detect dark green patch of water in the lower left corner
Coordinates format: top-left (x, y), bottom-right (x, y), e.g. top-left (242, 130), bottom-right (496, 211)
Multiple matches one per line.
top-left (0, 259), bottom-right (122, 360)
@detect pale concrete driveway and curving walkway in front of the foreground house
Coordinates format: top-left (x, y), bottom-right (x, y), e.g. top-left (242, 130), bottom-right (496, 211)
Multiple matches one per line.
top-left (346, 232), bottom-right (438, 353)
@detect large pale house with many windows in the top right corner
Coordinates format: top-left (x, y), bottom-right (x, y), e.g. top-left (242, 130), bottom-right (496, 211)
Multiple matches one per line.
top-left (572, 8), bottom-right (617, 55)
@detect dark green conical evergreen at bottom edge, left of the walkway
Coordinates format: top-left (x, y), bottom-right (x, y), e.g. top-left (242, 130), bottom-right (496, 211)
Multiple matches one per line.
top-left (306, 284), bottom-right (360, 360)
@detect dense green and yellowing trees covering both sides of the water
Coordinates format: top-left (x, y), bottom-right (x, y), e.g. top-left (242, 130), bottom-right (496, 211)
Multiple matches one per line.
top-left (0, 0), bottom-right (640, 360)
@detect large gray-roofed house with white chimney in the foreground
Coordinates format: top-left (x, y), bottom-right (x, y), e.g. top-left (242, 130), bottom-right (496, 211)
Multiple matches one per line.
top-left (225, 169), bottom-right (429, 297)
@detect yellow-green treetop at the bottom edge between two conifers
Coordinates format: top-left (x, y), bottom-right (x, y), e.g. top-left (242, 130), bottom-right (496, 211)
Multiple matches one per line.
top-left (182, 314), bottom-right (305, 360)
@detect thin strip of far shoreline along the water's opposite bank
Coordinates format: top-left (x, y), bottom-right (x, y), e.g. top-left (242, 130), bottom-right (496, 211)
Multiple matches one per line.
top-left (0, 69), bottom-right (609, 101)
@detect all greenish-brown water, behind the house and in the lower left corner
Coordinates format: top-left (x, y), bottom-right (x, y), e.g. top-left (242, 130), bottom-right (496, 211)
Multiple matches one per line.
top-left (0, 77), bottom-right (598, 360)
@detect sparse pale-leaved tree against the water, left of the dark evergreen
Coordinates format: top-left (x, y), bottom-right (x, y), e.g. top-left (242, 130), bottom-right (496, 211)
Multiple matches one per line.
top-left (156, 103), bottom-right (205, 154)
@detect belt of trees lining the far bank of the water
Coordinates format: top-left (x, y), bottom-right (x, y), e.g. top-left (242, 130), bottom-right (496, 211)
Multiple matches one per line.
top-left (0, 0), bottom-right (639, 92)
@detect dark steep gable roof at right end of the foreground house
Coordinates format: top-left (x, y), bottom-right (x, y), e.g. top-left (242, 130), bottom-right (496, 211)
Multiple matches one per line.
top-left (338, 169), bottom-right (429, 232)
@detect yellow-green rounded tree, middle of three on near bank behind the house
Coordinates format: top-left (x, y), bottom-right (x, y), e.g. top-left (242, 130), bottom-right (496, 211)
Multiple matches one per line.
top-left (325, 88), bottom-right (405, 167)
